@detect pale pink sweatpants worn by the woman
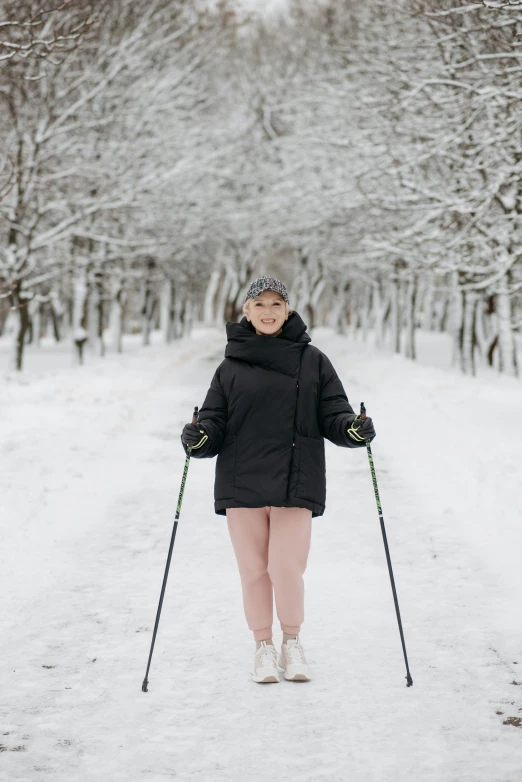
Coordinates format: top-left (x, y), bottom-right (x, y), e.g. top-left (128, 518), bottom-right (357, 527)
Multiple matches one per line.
top-left (227, 506), bottom-right (312, 641)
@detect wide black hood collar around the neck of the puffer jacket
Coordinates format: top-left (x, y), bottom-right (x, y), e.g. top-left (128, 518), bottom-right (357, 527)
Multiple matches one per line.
top-left (225, 312), bottom-right (312, 377)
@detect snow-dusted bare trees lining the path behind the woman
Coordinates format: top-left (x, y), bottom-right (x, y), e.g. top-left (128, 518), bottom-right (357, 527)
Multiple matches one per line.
top-left (0, 0), bottom-right (522, 375)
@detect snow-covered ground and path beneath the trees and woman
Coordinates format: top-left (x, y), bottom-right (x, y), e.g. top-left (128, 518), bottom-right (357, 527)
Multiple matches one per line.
top-left (0, 329), bottom-right (522, 782)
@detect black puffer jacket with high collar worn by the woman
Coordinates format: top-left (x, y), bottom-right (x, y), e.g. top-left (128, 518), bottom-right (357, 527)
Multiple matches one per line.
top-left (181, 312), bottom-right (364, 517)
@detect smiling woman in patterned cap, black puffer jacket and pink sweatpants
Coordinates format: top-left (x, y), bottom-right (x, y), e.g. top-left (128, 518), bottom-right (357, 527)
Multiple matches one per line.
top-left (181, 277), bottom-right (375, 683)
